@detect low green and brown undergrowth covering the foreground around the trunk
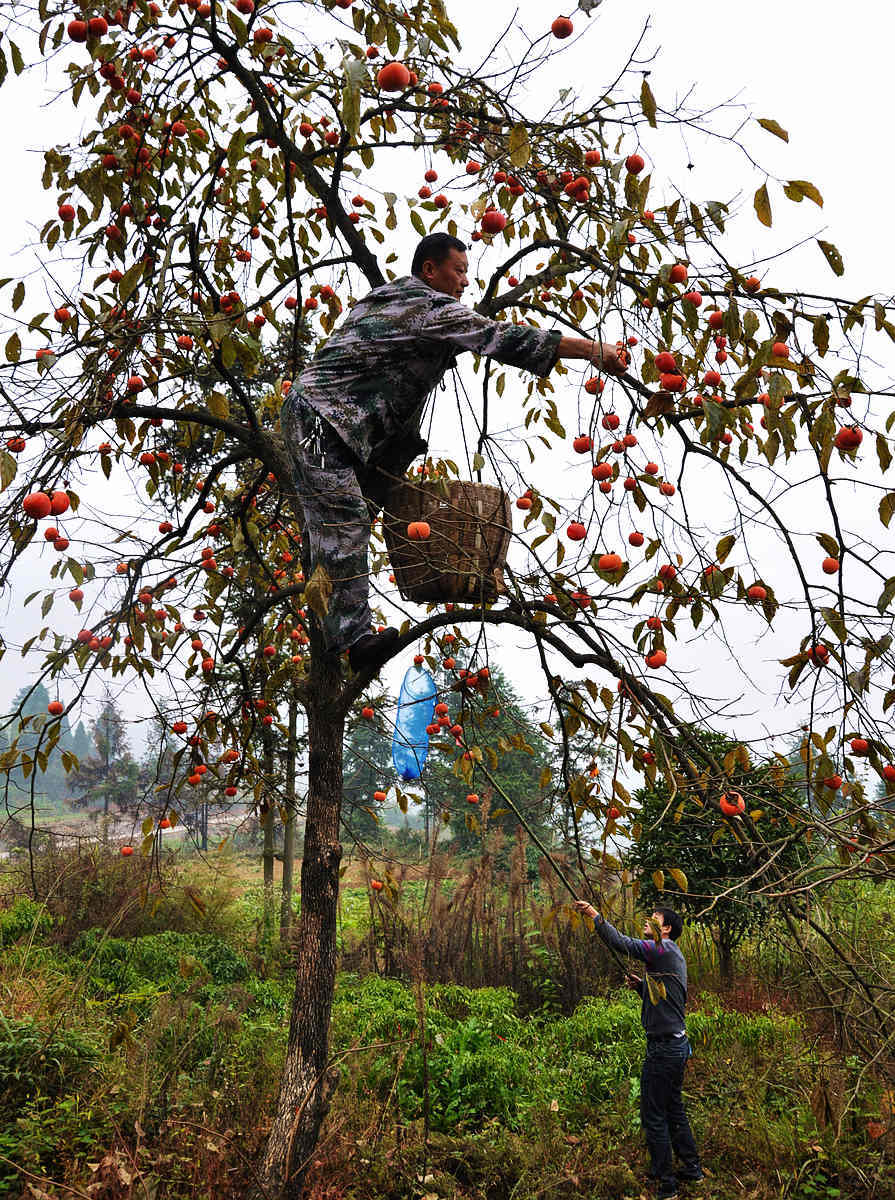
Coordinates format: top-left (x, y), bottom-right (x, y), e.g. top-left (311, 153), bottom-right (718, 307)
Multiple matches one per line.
top-left (0, 906), bottom-right (895, 1200)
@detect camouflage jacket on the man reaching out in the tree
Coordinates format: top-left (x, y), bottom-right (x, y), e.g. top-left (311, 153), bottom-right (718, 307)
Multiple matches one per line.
top-left (290, 275), bottom-right (561, 464)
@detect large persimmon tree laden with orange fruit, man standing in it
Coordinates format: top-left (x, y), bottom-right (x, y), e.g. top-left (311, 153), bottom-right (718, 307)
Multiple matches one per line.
top-left (0, 0), bottom-right (895, 1195)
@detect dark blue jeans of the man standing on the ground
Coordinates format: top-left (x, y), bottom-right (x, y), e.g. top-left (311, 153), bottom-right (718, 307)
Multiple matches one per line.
top-left (641, 1038), bottom-right (701, 1195)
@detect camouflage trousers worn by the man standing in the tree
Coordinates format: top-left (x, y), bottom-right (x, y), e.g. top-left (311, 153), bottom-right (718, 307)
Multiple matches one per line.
top-left (281, 389), bottom-right (416, 650)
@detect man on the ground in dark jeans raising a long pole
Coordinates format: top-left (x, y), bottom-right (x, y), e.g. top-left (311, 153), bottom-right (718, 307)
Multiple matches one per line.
top-left (575, 900), bottom-right (703, 1200)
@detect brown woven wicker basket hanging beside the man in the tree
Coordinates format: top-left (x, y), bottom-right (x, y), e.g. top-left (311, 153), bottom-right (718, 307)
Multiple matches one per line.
top-left (383, 480), bottom-right (512, 604)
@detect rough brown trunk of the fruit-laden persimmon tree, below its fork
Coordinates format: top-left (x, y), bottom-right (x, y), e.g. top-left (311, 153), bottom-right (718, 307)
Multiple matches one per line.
top-left (259, 653), bottom-right (344, 1200)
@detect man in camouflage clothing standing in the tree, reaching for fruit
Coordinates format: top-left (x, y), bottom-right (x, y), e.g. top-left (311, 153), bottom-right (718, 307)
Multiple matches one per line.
top-left (281, 233), bottom-right (621, 671)
